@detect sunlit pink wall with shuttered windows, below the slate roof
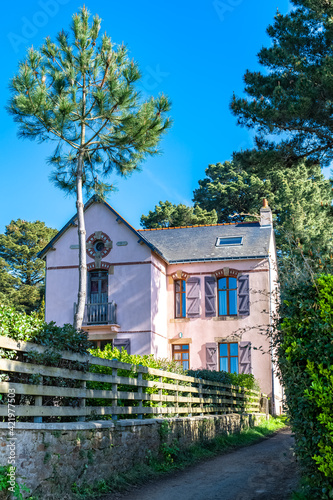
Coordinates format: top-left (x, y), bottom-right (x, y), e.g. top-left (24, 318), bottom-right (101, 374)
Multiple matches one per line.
top-left (168, 259), bottom-right (271, 393)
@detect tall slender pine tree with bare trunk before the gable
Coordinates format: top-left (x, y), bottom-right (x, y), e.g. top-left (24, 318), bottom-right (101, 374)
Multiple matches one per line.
top-left (8, 7), bottom-right (170, 328)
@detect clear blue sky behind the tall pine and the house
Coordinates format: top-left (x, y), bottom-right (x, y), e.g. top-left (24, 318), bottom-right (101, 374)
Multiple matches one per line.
top-left (0, 0), bottom-right (290, 232)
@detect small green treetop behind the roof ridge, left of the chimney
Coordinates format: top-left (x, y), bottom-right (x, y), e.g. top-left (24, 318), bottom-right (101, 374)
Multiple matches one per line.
top-left (140, 201), bottom-right (217, 229)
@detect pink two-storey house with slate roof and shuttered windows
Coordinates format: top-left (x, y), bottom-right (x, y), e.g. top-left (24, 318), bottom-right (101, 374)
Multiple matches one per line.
top-left (40, 198), bottom-right (282, 413)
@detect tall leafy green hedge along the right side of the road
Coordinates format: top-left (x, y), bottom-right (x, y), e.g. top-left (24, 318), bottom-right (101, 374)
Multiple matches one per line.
top-left (274, 275), bottom-right (333, 500)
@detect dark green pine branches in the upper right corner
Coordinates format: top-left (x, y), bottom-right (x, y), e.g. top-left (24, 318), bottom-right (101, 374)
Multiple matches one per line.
top-left (231, 0), bottom-right (333, 167)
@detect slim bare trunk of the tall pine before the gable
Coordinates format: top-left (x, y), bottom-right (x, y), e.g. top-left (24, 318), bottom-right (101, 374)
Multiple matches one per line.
top-left (74, 153), bottom-right (87, 330)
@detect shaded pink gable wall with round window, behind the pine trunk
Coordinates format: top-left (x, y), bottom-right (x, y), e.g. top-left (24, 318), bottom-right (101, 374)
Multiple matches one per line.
top-left (46, 203), bottom-right (166, 355)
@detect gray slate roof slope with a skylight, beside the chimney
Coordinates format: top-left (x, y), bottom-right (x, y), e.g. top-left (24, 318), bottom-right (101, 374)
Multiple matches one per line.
top-left (138, 222), bottom-right (272, 263)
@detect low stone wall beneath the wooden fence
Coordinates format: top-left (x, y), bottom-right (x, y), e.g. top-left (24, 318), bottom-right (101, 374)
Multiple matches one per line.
top-left (0, 414), bottom-right (266, 500)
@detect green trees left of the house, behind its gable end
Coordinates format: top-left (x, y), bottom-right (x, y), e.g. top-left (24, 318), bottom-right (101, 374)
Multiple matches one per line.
top-left (0, 219), bottom-right (57, 312)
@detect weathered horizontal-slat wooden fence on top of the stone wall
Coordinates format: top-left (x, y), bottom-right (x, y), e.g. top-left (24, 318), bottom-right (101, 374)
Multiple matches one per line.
top-left (0, 336), bottom-right (262, 422)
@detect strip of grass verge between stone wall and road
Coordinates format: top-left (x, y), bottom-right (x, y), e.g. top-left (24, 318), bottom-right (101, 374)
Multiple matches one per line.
top-left (72, 417), bottom-right (287, 500)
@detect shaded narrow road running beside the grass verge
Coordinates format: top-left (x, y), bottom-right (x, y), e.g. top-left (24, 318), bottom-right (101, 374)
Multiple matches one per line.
top-left (103, 429), bottom-right (298, 500)
